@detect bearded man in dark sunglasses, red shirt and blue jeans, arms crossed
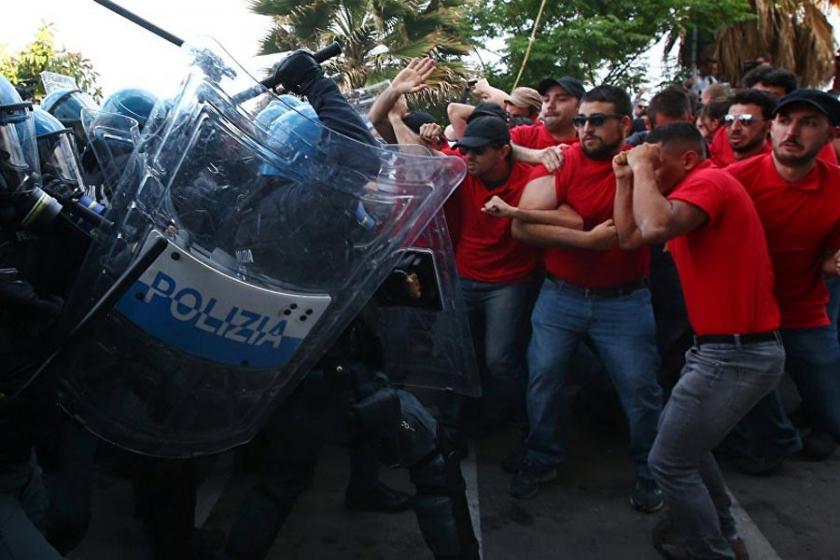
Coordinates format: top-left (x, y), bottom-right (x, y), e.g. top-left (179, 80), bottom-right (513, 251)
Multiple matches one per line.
top-left (498, 86), bottom-right (663, 512)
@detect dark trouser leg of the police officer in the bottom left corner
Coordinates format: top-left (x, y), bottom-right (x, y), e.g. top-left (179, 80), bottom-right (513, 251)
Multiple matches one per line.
top-left (0, 456), bottom-right (61, 560)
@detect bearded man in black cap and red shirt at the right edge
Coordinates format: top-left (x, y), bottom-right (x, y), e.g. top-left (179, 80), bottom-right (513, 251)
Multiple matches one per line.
top-left (726, 89), bottom-right (840, 466)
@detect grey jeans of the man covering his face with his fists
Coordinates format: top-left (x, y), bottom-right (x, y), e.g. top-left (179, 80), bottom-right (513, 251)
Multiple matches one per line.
top-left (648, 338), bottom-right (785, 559)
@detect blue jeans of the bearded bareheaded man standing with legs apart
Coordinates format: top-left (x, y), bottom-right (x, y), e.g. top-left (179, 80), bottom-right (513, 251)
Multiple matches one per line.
top-left (527, 278), bottom-right (662, 479)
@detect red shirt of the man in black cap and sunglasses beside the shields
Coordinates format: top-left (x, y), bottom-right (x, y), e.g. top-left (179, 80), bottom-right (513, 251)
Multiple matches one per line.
top-left (445, 163), bottom-right (539, 284)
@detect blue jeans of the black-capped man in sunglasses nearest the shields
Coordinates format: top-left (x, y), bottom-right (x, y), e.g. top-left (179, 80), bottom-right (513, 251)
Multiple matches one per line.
top-left (461, 278), bottom-right (532, 419)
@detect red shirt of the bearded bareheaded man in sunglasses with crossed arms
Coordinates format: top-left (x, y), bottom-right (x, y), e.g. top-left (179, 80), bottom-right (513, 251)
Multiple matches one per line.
top-left (532, 144), bottom-right (650, 289)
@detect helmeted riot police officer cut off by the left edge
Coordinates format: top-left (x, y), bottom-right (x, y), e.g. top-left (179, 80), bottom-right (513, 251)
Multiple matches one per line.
top-left (0, 76), bottom-right (62, 559)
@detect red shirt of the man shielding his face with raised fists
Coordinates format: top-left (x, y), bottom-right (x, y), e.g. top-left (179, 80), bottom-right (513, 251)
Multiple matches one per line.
top-left (668, 160), bottom-right (779, 335)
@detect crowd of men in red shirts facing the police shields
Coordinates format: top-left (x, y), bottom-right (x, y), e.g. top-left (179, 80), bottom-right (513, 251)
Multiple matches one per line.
top-left (369, 54), bottom-right (840, 559)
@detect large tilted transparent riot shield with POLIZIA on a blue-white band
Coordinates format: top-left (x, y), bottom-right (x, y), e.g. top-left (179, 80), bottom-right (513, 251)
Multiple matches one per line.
top-left (55, 38), bottom-right (465, 457)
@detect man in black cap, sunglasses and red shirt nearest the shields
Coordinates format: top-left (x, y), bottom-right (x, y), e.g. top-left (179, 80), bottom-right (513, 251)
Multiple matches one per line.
top-left (446, 116), bottom-right (560, 434)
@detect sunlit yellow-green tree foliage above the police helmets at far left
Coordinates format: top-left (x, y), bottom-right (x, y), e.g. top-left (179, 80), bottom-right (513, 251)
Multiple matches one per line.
top-left (0, 23), bottom-right (102, 102)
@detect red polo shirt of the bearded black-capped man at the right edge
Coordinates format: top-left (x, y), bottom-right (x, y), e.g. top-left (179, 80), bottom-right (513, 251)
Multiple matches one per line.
top-left (726, 154), bottom-right (840, 328)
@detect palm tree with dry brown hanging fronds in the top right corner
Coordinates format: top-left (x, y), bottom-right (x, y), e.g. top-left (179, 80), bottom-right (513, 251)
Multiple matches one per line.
top-left (681, 0), bottom-right (840, 87)
